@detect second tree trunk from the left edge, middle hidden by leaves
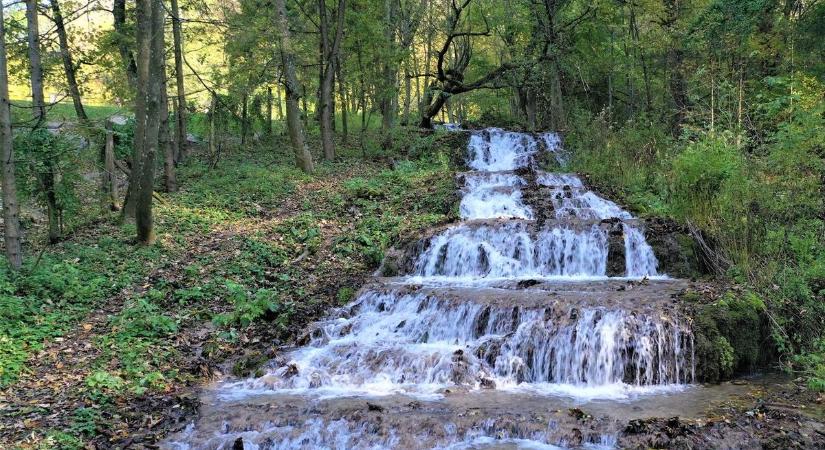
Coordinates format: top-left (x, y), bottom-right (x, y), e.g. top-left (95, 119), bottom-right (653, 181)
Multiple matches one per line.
top-left (26, 0), bottom-right (61, 243)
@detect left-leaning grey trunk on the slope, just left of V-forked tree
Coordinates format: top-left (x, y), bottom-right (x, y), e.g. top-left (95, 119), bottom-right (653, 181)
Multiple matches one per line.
top-left (275, 0), bottom-right (315, 173)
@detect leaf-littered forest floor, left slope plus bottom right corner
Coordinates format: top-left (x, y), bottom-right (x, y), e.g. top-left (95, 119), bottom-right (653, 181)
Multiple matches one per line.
top-left (0, 132), bottom-right (825, 448)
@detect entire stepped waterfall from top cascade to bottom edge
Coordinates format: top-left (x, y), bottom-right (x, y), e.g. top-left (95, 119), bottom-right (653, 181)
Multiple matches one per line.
top-left (166, 129), bottom-right (697, 449)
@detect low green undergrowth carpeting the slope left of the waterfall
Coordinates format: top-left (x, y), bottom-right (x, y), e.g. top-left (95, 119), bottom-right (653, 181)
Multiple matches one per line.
top-left (0, 127), bottom-right (457, 448)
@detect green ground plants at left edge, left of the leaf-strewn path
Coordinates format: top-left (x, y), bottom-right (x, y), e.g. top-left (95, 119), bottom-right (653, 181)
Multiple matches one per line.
top-left (0, 228), bottom-right (167, 385)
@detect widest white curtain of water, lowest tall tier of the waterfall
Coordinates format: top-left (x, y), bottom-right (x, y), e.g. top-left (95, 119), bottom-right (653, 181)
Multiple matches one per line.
top-left (224, 290), bottom-right (693, 398)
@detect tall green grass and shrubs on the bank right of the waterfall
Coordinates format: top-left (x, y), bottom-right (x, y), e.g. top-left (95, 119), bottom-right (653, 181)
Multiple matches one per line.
top-left (567, 75), bottom-right (825, 379)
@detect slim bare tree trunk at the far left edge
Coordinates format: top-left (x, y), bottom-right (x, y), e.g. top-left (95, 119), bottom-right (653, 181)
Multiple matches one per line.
top-left (0, 3), bottom-right (23, 270)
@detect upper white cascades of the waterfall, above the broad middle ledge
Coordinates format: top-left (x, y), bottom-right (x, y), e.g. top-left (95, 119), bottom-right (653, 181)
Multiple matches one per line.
top-left (415, 128), bottom-right (658, 278)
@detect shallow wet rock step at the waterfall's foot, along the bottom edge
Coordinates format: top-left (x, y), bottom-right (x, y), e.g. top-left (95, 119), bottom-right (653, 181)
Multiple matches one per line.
top-left (161, 384), bottom-right (764, 450)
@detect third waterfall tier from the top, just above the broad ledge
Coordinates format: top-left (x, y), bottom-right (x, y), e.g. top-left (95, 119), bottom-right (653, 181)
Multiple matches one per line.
top-left (379, 217), bottom-right (656, 277)
